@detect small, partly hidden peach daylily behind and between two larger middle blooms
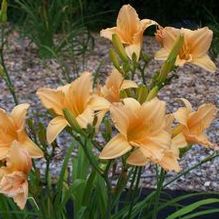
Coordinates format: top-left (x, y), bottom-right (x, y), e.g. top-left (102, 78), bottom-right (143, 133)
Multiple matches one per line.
top-left (99, 69), bottom-right (137, 103)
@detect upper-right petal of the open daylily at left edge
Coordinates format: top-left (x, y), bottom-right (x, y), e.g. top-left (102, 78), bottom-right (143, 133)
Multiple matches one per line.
top-left (11, 103), bottom-right (30, 129)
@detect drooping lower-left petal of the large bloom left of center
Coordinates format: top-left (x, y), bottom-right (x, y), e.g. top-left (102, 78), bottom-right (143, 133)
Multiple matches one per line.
top-left (46, 116), bottom-right (68, 144)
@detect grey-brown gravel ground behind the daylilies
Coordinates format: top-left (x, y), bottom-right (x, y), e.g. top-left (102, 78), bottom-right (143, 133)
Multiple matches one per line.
top-left (0, 33), bottom-right (219, 191)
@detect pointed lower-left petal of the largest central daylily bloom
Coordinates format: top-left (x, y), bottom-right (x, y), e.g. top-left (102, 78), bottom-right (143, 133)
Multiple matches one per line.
top-left (99, 134), bottom-right (132, 159)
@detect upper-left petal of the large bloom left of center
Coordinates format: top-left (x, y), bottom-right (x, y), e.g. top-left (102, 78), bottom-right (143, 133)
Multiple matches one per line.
top-left (37, 88), bottom-right (64, 115)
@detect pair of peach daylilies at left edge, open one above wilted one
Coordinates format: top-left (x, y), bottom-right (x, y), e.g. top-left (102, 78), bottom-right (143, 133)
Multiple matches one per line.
top-left (0, 104), bottom-right (43, 209)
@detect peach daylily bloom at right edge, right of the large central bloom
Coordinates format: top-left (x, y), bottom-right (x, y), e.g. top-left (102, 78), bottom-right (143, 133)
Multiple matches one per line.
top-left (174, 98), bottom-right (217, 146)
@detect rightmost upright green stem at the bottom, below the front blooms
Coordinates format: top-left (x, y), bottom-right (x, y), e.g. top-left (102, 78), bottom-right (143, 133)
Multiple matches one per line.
top-left (152, 169), bottom-right (166, 219)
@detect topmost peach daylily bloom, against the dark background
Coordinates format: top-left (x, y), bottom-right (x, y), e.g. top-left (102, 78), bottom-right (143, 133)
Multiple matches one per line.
top-left (100, 5), bottom-right (157, 58)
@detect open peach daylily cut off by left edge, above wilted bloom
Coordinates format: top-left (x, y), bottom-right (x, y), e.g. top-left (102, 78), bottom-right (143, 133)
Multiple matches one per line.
top-left (0, 104), bottom-right (43, 160)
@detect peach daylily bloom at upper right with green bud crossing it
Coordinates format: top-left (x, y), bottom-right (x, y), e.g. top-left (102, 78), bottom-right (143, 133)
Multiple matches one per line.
top-left (155, 27), bottom-right (216, 72)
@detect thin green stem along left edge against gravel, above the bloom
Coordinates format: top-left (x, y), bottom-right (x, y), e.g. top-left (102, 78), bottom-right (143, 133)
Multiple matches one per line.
top-left (0, 24), bottom-right (18, 105)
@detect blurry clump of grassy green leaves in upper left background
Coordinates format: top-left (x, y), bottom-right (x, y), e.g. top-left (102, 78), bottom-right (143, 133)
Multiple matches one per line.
top-left (16, 0), bottom-right (90, 58)
